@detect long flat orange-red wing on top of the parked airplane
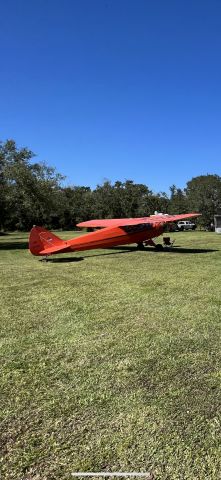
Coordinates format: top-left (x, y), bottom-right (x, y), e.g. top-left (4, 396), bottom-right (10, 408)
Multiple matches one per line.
top-left (77, 213), bottom-right (201, 228)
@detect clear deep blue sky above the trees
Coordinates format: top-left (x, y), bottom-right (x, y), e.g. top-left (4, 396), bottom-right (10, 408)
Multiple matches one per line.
top-left (0, 0), bottom-right (221, 191)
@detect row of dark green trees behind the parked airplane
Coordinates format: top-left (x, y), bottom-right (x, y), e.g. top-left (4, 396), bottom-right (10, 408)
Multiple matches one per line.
top-left (0, 140), bottom-right (221, 231)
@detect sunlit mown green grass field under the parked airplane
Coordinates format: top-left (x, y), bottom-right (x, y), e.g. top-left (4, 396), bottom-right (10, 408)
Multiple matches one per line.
top-left (0, 232), bottom-right (221, 480)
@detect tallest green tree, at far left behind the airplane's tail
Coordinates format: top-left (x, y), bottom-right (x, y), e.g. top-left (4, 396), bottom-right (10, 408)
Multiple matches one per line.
top-left (0, 140), bottom-right (63, 229)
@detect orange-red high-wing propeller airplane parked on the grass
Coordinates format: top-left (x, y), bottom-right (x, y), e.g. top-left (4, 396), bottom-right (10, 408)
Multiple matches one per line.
top-left (29, 213), bottom-right (200, 258)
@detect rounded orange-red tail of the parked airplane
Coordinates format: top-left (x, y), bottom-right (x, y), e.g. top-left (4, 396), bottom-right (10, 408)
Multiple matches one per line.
top-left (29, 226), bottom-right (66, 255)
